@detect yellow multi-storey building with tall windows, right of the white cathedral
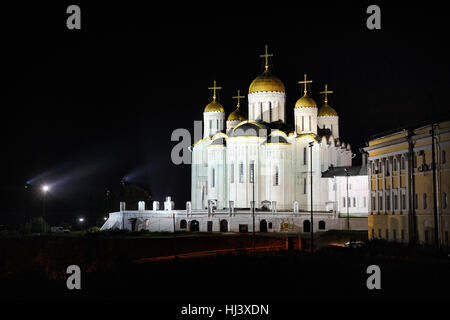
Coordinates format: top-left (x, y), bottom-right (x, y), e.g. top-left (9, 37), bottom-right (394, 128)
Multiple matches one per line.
top-left (364, 121), bottom-right (450, 246)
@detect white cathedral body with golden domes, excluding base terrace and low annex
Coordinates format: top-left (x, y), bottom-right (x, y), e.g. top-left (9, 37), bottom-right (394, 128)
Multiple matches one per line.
top-left (191, 49), bottom-right (367, 212)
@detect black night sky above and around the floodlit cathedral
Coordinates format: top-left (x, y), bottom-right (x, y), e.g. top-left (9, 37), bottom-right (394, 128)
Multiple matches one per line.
top-left (0, 1), bottom-right (450, 224)
